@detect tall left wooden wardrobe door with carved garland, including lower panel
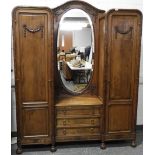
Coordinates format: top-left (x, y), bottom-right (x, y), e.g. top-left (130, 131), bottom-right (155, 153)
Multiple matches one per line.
top-left (13, 7), bottom-right (53, 146)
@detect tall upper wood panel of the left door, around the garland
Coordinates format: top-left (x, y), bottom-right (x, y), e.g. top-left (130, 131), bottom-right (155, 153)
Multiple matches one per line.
top-left (19, 13), bottom-right (48, 102)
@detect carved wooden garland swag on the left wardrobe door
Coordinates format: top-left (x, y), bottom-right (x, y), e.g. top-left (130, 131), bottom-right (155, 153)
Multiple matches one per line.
top-left (23, 25), bottom-right (44, 38)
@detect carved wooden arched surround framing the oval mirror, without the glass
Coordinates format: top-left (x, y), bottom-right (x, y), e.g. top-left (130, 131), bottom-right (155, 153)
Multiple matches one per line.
top-left (53, 1), bottom-right (105, 96)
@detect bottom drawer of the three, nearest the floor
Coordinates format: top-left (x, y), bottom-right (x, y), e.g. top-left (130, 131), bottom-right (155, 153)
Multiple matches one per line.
top-left (57, 127), bottom-right (100, 137)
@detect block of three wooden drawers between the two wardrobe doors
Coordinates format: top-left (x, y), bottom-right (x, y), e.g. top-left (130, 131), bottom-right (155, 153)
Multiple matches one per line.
top-left (56, 98), bottom-right (101, 142)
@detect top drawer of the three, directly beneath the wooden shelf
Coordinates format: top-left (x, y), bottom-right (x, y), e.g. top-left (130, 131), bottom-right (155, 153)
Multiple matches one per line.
top-left (57, 107), bottom-right (100, 118)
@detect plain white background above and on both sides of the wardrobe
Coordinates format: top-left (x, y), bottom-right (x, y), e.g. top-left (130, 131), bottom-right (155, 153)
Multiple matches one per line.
top-left (0, 0), bottom-right (155, 154)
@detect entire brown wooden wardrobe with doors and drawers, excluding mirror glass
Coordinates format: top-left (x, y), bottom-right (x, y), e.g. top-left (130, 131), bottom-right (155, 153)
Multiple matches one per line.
top-left (12, 1), bottom-right (142, 153)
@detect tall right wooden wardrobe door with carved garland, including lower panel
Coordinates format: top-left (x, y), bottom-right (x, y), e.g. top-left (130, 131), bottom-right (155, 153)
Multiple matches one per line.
top-left (106, 10), bottom-right (142, 139)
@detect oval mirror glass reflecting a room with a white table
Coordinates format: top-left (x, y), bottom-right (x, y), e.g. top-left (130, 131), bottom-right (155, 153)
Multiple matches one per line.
top-left (57, 9), bottom-right (94, 93)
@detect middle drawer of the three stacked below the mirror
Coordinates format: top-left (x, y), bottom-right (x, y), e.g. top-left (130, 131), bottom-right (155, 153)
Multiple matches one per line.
top-left (57, 118), bottom-right (100, 128)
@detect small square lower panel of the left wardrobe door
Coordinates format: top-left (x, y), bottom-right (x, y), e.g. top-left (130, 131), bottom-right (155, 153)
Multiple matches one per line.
top-left (23, 107), bottom-right (49, 138)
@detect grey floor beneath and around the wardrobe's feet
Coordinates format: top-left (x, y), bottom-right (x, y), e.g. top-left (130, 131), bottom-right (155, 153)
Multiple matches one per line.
top-left (11, 131), bottom-right (143, 155)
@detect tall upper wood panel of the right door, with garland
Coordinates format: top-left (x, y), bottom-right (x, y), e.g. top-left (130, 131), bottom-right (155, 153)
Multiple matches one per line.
top-left (109, 15), bottom-right (137, 100)
